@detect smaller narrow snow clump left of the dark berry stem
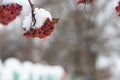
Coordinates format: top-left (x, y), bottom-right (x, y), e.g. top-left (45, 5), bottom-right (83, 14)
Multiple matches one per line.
top-left (23, 13), bottom-right (32, 31)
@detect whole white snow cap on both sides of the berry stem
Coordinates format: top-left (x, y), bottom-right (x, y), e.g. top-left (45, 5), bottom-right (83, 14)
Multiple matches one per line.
top-left (23, 8), bottom-right (52, 31)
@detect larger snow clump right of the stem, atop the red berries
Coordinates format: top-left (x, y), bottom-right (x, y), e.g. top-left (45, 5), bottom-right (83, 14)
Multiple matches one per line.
top-left (34, 8), bottom-right (52, 28)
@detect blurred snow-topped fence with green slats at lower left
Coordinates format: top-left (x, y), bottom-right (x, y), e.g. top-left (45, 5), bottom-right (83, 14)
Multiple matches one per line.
top-left (0, 58), bottom-right (64, 80)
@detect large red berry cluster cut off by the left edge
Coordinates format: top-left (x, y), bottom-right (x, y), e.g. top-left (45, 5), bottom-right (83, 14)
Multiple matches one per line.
top-left (0, 3), bottom-right (22, 25)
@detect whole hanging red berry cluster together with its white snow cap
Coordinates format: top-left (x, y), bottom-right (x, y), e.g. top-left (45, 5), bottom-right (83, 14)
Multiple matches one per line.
top-left (23, 8), bottom-right (59, 39)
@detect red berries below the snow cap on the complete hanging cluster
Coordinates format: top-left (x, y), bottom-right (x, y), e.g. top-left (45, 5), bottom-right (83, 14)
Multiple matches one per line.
top-left (23, 18), bottom-right (59, 39)
